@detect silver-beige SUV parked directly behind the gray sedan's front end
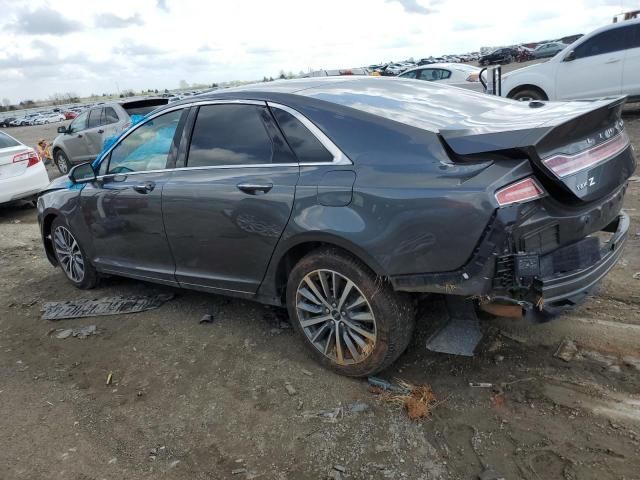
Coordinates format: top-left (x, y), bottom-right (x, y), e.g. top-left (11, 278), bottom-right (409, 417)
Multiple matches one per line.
top-left (51, 98), bottom-right (167, 174)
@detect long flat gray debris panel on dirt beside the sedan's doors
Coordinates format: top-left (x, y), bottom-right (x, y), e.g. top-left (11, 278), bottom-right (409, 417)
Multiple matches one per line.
top-left (42, 293), bottom-right (173, 320)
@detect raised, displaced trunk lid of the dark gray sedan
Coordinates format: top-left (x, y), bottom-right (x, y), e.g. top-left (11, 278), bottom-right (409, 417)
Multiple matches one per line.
top-left (439, 97), bottom-right (635, 203)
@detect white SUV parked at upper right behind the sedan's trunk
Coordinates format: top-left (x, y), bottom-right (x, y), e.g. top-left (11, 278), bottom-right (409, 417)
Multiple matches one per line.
top-left (502, 20), bottom-right (640, 101)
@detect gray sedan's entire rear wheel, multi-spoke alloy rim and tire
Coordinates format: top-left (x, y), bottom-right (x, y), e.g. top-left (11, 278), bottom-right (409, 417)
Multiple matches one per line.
top-left (287, 249), bottom-right (415, 376)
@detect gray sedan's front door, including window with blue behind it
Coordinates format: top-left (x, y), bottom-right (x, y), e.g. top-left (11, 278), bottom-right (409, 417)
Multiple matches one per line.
top-left (81, 110), bottom-right (184, 284)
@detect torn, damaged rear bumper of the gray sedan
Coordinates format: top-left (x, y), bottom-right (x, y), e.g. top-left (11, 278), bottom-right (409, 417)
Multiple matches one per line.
top-left (391, 189), bottom-right (630, 319)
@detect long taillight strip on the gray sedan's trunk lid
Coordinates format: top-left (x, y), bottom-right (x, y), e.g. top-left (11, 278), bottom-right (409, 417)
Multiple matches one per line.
top-left (542, 131), bottom-right (629, 178)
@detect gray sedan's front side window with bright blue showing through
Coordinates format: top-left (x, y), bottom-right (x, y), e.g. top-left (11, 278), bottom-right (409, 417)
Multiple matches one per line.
top-left (108, 110), bottom-right (182, 174)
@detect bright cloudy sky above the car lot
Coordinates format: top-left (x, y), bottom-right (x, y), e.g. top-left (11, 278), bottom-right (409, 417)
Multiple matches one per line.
top-left (0, 0), bottom-right (640, 102)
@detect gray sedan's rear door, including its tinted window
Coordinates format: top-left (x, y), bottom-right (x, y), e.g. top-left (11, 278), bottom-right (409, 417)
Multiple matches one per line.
top-left (162, 101), bottom-right (299, 293)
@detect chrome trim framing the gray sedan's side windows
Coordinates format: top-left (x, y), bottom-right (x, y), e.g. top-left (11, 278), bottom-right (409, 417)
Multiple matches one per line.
top-left (96, 99), bottom-right (353, 176)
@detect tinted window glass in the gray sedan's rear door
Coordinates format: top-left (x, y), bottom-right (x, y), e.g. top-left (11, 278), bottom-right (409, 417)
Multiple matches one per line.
top-left (187, 104), bottom-right (273, 167)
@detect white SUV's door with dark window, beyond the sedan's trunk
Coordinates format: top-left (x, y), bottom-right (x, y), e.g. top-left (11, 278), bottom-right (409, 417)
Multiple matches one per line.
top-left (556, 26), bottom-right (631, 100)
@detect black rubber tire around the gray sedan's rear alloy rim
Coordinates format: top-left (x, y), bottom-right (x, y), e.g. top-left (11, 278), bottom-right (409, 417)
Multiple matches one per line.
top-left (287, 248), bottom-right (415, 377)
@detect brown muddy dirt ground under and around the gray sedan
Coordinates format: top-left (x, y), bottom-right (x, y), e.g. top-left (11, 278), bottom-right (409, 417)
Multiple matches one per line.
top-left (0, 91), bottom-right (640, 480)
